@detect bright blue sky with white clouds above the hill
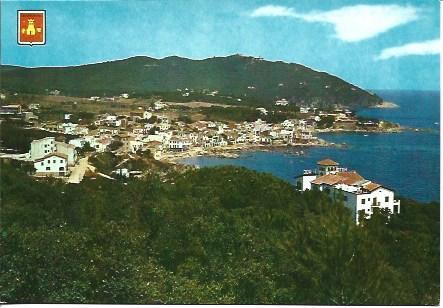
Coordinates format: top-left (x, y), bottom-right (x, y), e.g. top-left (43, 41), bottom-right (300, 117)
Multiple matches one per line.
top-left (0, 0), bottom-right (440, 90)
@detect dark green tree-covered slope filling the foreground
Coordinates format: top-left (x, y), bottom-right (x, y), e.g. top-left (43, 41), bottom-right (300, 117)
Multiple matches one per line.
top-left (0, 163), bottom-right (439, 305)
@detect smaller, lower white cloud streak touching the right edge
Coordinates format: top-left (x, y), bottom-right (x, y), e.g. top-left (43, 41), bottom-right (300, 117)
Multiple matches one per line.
top-left (376, 39), bottom-right (440, 60)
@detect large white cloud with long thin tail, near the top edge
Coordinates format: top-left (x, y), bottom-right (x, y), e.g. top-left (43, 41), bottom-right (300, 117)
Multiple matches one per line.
top-left (249, 5), bottom-right (419, 42)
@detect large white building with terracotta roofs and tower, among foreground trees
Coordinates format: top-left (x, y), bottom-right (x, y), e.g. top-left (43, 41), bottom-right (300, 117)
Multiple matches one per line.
top-left (296, 159), bottom-right (400, 224)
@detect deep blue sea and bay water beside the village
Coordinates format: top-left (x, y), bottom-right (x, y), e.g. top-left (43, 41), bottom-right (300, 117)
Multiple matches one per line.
top-left (181, 90), bottom-right (440, 202)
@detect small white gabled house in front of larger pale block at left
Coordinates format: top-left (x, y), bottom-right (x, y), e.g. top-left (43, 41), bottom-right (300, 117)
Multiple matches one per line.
top-left (34, 153), bottom-right (69, 176)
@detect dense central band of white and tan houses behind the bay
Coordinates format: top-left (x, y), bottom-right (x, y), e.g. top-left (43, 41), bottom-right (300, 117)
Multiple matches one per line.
top-left (10, 102), bottom-right (326, 159)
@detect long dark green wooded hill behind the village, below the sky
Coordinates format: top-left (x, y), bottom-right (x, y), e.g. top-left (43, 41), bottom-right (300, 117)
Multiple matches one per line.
top-left (0, 55), bottom-right (381, 108)
